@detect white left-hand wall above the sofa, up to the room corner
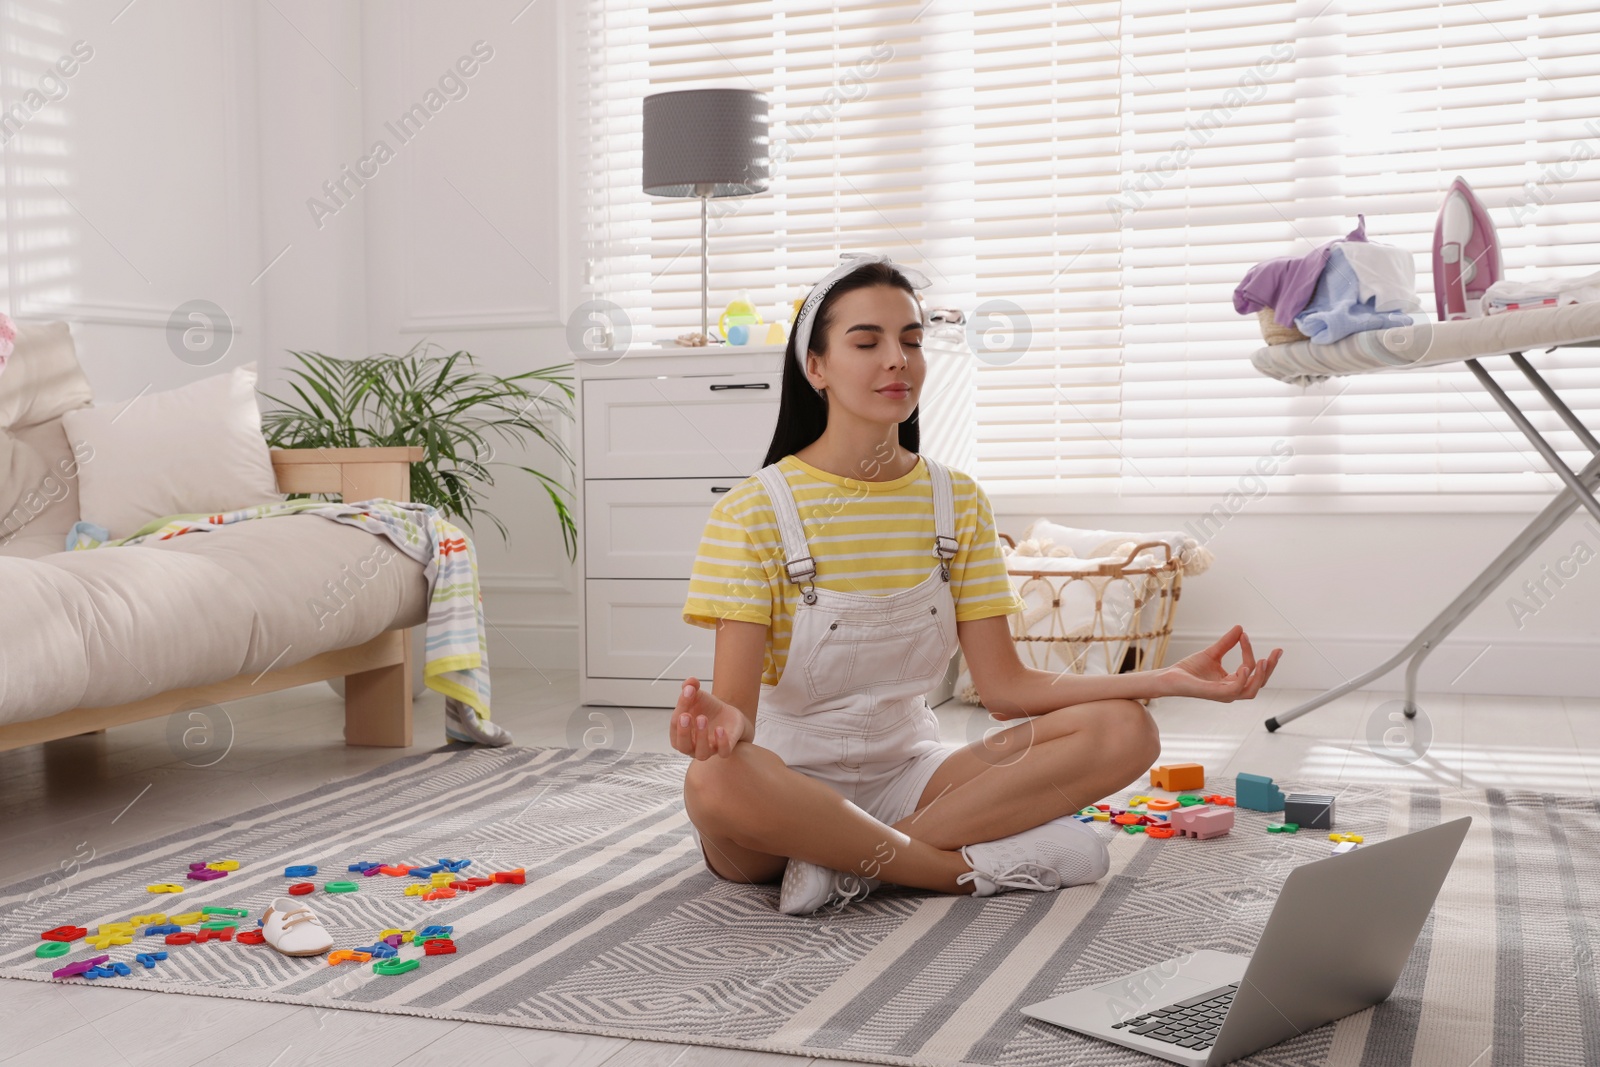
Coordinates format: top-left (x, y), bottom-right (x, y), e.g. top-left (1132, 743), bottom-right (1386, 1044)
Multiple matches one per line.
top-left (0, 0), bottom-right (261, 398)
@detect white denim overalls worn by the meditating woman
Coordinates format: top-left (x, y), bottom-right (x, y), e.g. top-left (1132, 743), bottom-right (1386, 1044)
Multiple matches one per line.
top-left (739, 456), bottom-right (962, 824)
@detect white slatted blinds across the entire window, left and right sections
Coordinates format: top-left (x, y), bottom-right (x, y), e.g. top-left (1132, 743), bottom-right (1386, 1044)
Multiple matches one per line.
top-left (574, 0), bottom-right (1600, 509)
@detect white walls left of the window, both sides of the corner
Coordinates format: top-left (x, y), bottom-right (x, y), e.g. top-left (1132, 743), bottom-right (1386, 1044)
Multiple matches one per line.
top-left (0, 0), bottom-right (578, 667)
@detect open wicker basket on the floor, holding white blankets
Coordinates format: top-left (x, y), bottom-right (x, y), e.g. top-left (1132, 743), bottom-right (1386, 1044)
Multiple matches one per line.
top-left (1000, 533), bottom-right (1184, 673)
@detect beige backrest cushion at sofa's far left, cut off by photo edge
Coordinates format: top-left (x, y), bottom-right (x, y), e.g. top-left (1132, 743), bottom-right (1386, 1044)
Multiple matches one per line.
top-left (0, 322), bottom-right (94, 545)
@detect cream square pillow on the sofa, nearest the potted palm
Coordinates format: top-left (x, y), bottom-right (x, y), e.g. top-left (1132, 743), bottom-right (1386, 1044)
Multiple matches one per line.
top-left (62, 363), bottom-right (283, 537)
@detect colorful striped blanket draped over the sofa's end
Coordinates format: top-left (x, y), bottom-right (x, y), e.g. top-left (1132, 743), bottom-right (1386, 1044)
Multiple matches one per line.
top-left (67, 499), bottom-right (490, 718)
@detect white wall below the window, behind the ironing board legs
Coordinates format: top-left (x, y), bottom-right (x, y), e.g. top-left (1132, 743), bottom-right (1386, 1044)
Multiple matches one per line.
top-left (995, 505), bottom-right (1600, 696)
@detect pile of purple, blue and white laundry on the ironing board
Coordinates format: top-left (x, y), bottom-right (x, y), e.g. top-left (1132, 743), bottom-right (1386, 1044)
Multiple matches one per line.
top-left (1234, 216), bottom-right (1422, 344)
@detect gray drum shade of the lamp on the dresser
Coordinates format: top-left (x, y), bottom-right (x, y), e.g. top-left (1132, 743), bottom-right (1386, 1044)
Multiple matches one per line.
top-left (643, 90), bottom-right (770, 197)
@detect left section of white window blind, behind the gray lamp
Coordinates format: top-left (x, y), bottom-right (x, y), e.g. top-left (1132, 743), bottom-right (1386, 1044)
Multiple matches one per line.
top-left (579, 0), bottom-right (971, 341)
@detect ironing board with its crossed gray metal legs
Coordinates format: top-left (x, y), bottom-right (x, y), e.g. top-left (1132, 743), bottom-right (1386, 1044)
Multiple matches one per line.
top-left (1250, 304), bottom-right (1600, 731)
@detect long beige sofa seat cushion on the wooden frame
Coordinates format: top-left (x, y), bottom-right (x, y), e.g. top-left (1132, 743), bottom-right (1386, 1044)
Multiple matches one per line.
top-left (0, 515), bottom-right (429, 725)
